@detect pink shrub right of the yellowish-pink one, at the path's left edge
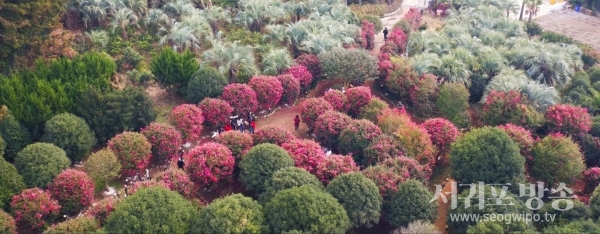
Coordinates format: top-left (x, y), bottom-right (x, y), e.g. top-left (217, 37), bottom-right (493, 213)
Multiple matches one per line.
top-left (140, 123), bottom-right (183, 161)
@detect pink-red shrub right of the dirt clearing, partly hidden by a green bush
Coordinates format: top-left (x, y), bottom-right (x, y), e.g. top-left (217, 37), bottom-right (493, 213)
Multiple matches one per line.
top-left (313, 110), bottom-right (352, 148)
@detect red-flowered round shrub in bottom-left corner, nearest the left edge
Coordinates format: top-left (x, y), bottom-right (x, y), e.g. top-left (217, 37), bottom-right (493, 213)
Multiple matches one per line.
top-left (10, 188), bottom-right (60, 230)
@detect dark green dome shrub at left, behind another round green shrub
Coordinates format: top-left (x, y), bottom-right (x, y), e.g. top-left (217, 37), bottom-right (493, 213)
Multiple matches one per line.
top-left (41, 113), bottom-right (96, 161)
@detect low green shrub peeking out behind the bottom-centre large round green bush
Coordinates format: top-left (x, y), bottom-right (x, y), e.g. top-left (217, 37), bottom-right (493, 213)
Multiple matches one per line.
top-left (259, 167), bottom-right (323, 203)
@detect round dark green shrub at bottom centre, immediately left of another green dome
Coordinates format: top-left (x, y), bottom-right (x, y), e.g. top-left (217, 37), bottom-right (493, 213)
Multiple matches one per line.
top-left (326, 172), bottom-right (383, 227)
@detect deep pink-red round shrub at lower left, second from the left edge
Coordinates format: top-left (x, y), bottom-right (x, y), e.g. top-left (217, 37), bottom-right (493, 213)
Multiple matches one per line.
top-left (48, 169), bottom-right (95, 214)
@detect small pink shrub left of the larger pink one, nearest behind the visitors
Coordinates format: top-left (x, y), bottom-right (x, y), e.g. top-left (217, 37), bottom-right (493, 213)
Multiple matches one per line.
top-left (198, 98), bottom-right (233, 127)
